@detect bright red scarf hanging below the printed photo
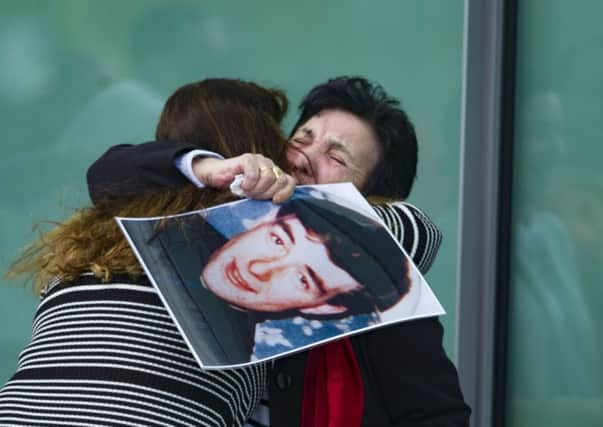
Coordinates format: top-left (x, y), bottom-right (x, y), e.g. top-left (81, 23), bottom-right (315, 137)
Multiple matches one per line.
top-left (301, 338), bottom-right (364, 427)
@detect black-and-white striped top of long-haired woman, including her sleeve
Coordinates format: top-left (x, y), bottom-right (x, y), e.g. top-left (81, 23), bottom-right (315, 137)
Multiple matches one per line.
top-left (0, 203), bottom-right (441, 427)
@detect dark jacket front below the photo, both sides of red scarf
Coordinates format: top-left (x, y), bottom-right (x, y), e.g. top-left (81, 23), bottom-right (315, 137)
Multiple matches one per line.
top-left (269, 317), bottom-right (471, 427)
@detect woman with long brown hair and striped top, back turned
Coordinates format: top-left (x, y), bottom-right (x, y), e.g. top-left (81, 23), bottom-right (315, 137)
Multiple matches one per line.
top-left (0, 79), bottom-right (293, 426)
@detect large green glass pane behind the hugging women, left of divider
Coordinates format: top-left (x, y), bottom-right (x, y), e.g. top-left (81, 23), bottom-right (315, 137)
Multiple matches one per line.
top-left (0, 0), bottom-right (463, 383)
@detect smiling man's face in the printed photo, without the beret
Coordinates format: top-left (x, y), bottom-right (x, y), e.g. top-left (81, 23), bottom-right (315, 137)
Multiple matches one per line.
top-left (201, 214), bottom-right (361, 314)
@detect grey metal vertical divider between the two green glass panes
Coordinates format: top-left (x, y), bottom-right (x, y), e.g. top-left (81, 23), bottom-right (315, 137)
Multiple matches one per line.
top-left (455, 0), bottom-right (517, 427)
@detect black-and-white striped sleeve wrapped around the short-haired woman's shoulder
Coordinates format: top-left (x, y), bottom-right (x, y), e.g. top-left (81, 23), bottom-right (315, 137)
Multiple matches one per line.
top-left (373, 202), bottom-right (442, 273)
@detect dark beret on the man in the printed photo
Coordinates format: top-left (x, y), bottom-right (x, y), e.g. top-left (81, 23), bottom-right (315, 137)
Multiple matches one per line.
top-left (277, 197), bottom-right (410, 318)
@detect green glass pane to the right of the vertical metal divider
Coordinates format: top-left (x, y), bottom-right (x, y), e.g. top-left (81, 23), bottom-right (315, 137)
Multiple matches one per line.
top-left (507, 0), bottom-right (603, 427)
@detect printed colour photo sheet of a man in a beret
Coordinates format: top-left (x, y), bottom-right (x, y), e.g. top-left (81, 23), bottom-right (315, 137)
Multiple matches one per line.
top-left (117, 183), bottom-right (444, 369)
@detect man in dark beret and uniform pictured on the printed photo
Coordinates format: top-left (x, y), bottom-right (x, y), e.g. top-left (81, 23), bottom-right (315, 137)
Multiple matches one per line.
top-left (135, 197), bottom-right (411, 364)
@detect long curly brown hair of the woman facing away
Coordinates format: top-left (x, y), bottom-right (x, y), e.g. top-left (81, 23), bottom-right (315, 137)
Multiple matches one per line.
top-left (6, 79), bottom-right (288, 293)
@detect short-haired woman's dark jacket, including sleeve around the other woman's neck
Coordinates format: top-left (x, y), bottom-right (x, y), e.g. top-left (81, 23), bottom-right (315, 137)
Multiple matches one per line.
top-left (87, 141), bottom-right (471, 427)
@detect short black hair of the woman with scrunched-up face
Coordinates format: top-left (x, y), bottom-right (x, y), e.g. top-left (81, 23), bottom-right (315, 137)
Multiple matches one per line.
top-left (291, 76), bottom-right (418, 199)
